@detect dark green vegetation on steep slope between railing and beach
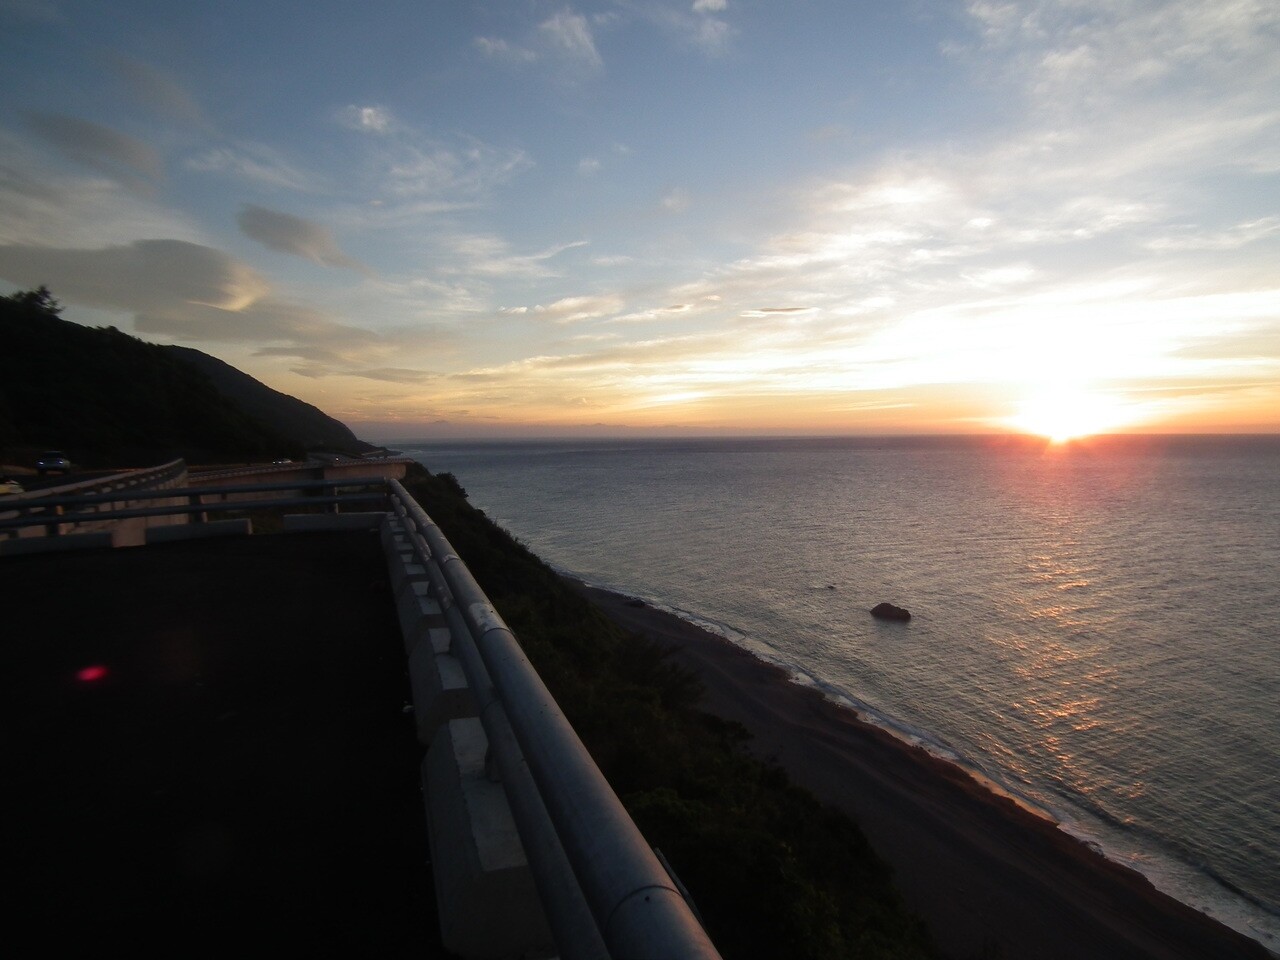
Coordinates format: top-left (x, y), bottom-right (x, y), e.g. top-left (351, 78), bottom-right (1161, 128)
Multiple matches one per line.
top-left (406, 468), bottom-right (933, 959)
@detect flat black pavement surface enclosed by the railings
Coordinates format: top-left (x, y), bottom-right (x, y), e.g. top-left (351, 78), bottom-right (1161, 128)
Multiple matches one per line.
top-left (0, 532), bottom-right (453, 956)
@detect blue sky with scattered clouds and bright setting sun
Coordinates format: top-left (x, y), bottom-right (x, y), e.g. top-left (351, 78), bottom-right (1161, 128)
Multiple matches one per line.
top-left (0, 0), bottom-right (1280, 439)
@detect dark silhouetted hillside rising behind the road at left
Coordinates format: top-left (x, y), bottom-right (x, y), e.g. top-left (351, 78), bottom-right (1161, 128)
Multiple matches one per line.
top-left (0, 289), bottom-right (365, 466)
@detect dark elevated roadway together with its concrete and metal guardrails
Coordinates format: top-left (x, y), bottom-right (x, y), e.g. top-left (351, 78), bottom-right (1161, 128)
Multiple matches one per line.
top-left (0, 476), bottom-right (718, 960)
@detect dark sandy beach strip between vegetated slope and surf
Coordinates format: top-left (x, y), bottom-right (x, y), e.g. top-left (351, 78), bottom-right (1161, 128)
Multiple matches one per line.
top-left (564, 576), bottom-right (1275, 960)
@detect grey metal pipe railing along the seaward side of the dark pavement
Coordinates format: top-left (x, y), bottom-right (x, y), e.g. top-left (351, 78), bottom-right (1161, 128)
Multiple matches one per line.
top-left (389, 480), bottom-right (719, 960)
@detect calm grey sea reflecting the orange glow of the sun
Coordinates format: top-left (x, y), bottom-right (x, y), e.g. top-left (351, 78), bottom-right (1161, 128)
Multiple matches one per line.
top-left (399, 438), bottom-right (1280, 950)
